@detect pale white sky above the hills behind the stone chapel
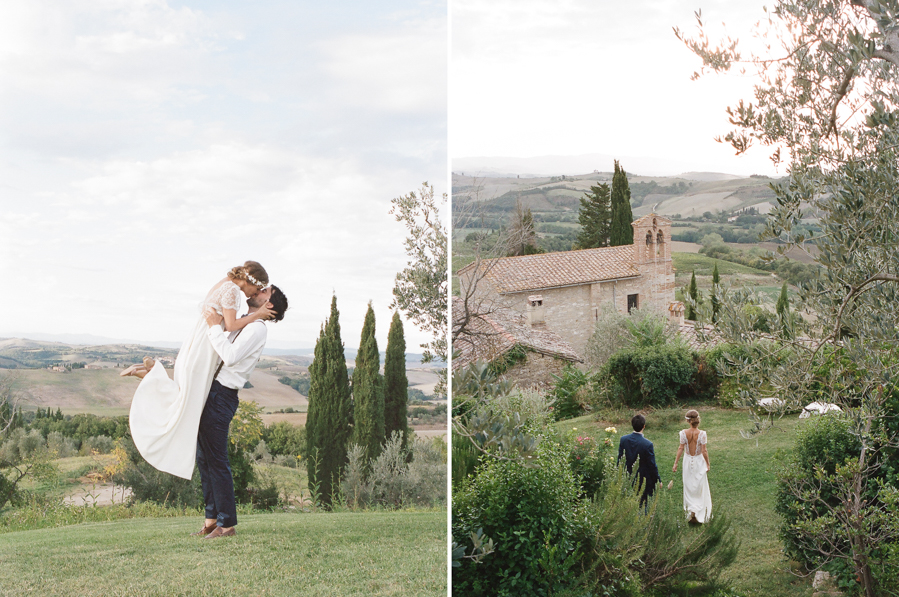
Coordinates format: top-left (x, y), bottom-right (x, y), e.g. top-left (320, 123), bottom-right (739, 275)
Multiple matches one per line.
top-left (449, 0), bottom-right (783, 175)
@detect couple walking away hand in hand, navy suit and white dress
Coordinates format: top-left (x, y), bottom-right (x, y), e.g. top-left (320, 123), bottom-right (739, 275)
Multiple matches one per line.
top-left (618, 410), bottom-right (712, 523)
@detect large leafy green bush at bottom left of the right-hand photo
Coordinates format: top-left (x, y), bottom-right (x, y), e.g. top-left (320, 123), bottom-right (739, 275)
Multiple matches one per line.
top-left (452, 441), bottom-right (583, 596)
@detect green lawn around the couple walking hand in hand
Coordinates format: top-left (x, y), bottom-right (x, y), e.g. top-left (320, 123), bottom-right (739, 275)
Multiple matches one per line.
top-left (558, 408), bottom-right (812, 597)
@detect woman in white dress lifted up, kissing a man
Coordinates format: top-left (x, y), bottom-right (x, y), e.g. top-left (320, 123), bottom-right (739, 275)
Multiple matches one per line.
top-left (121, 261), bottom-right (271, 479)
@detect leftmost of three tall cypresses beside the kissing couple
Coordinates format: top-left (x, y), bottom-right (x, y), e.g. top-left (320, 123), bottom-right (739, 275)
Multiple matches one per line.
top-left (306, 296), bottom-right (353, 506)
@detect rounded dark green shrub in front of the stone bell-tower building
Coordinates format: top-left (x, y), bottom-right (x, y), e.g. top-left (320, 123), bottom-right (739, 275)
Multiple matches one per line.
top-left (602, 344), bottom-right (696, 407)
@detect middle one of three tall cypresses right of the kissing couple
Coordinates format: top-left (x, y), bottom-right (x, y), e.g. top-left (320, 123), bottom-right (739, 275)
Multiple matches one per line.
top-left (353, 303), bottom-right (386, 461)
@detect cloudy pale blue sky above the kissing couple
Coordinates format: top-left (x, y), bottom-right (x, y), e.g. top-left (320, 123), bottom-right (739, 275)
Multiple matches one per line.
top-left (0, 0), bottom-right (447, 351)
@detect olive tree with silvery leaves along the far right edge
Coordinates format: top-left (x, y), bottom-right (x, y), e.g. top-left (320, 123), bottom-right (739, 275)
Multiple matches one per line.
top-left (675, 0), bottom-right (899, 597)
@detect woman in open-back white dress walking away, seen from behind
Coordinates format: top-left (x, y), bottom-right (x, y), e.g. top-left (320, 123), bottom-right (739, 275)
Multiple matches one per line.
top-left (671, 410), bottom-right (712, 523)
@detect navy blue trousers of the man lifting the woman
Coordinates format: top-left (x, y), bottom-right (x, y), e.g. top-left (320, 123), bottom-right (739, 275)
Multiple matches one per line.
top-left (197, 380), bottom-right (238, 528)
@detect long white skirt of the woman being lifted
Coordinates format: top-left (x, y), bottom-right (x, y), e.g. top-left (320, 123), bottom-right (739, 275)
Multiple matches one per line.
top-left (128, 317), bottom-right (220, 479)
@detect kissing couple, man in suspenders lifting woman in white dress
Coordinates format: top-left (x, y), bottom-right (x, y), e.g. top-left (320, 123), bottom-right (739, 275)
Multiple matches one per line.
top-left (122, 261), bottom-right (287, 539)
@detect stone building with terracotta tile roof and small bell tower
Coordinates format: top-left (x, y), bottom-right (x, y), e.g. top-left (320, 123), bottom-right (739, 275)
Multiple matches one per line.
top-left (453, 213), bottom-right (684, 386)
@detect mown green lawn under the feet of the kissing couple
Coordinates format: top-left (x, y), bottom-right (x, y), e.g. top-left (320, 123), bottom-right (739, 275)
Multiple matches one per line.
top-left (0, 511), bottom-right (447, 597)
